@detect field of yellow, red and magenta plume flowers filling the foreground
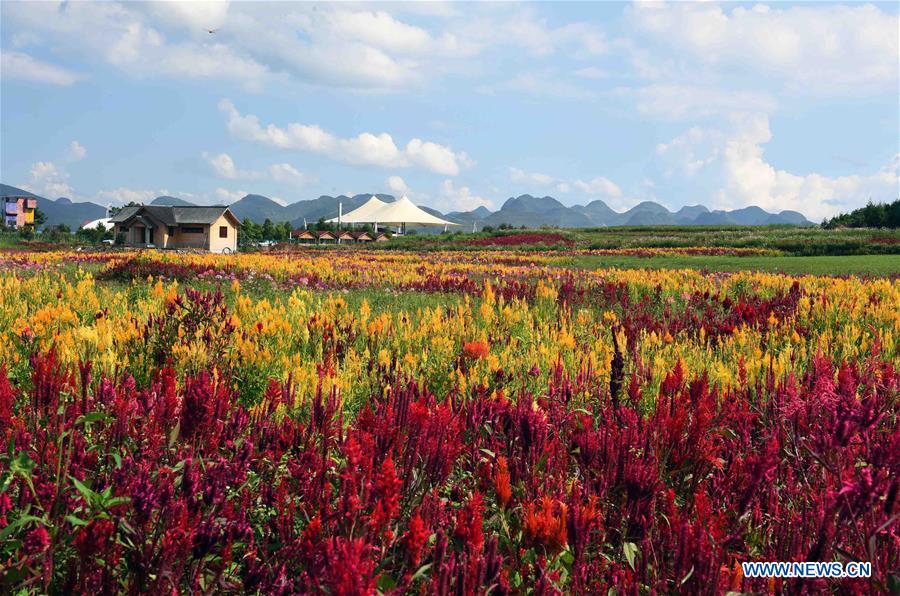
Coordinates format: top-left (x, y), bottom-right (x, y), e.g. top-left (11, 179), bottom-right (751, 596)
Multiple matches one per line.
top-left (0, 247), bottom-right (900, 594)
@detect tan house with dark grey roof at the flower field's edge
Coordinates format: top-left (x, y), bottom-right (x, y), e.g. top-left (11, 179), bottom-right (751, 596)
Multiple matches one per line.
top-left (110, 205), bottom-right (240, 253)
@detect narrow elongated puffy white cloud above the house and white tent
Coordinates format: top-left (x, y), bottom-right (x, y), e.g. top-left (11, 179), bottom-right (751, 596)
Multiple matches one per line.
top-left (219, 100), bottom-right (471, 176)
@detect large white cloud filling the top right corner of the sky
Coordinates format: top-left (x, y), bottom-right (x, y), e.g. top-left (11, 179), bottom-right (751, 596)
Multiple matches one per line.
top-left (626, 2), bottom-right (900, 96)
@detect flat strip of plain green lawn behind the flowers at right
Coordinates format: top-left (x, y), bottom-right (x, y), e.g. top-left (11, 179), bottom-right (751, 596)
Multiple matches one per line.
top-left (556, 255), bottom-right (900, 276)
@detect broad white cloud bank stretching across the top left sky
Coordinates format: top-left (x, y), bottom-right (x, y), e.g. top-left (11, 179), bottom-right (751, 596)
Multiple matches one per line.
top-left (4, 2), bottom-right (607, 92)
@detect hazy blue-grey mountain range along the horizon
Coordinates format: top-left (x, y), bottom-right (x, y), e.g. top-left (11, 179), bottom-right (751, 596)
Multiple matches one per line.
top-left (0, 184), bottom-right (814, 230)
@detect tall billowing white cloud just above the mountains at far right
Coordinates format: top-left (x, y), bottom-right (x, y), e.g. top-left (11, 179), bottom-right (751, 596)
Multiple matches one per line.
top-left (657, 113), bottom-right (900, 220)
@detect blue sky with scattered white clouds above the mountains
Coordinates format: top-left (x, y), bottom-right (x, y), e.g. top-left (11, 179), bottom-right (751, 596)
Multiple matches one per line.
top-left (0, 2), bottom-right (900, 219)
